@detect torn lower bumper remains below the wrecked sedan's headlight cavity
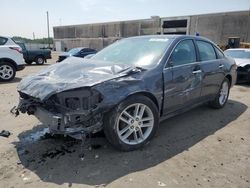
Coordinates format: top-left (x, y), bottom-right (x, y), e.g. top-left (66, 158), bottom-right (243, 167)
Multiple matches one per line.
top-left (10, 102), bottom-right (103, 139)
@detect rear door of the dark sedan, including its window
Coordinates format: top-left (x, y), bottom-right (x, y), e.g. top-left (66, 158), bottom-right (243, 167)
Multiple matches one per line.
top-left (196, 40), bottom-right (224, 98)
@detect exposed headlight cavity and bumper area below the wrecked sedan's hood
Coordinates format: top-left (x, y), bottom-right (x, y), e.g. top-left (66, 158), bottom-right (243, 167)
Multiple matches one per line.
top-left (17, 88), bottom-right (103, 137)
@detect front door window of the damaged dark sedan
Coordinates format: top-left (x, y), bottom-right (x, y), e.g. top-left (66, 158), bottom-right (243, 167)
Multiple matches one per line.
top-left (171, 40), bottom-right (196, 66)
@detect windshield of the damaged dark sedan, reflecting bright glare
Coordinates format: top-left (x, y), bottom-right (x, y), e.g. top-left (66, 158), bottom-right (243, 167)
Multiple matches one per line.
top-left (91, 37), bottom-right (172, 68)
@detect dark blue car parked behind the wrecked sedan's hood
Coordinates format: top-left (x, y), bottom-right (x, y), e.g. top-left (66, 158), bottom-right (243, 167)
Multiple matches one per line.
top-left (57, 47), bottom-right (97, 62)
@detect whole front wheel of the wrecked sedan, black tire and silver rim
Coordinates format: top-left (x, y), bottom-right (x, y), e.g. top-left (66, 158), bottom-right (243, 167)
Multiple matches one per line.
top-left (104, 95), bottom-right (159, 151)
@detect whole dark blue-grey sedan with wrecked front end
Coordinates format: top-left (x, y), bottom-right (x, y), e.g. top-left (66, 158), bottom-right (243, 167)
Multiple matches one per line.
top-left (16, 35), bottom-right (236, 151)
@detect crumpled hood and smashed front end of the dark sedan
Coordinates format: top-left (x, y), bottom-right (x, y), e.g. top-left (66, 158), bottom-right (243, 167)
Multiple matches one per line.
top-left (12, 58), bottom-right (147, 138)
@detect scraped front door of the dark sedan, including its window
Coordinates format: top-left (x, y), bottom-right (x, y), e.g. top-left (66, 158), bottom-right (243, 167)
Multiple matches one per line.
top-left (163, 39), bottom-right (202, 114)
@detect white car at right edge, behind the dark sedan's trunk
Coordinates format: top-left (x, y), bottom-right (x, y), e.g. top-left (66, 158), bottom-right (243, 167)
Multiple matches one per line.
top-left (224, 48), bottom-right (250, 83)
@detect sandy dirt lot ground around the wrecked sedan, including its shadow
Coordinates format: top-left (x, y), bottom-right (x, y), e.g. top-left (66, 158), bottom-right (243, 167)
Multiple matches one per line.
top-left (0, 53), bottom-right (250, 188)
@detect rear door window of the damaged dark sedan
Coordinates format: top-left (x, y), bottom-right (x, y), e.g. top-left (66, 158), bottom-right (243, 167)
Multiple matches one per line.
top-left (197, 41), bottom-right (216, 61)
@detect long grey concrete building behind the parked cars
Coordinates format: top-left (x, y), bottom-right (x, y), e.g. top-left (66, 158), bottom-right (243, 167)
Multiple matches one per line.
top-left (53, 11), bottom-right (250, 51)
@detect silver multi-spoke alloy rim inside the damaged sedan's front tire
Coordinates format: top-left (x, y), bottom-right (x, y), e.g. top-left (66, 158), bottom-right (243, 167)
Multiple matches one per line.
top-left (116, 103), bottom-right (154, 145)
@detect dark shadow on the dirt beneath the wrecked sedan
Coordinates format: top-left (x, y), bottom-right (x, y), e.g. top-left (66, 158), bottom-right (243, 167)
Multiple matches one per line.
top-left (14, 100), bottom-right (247, 185)
